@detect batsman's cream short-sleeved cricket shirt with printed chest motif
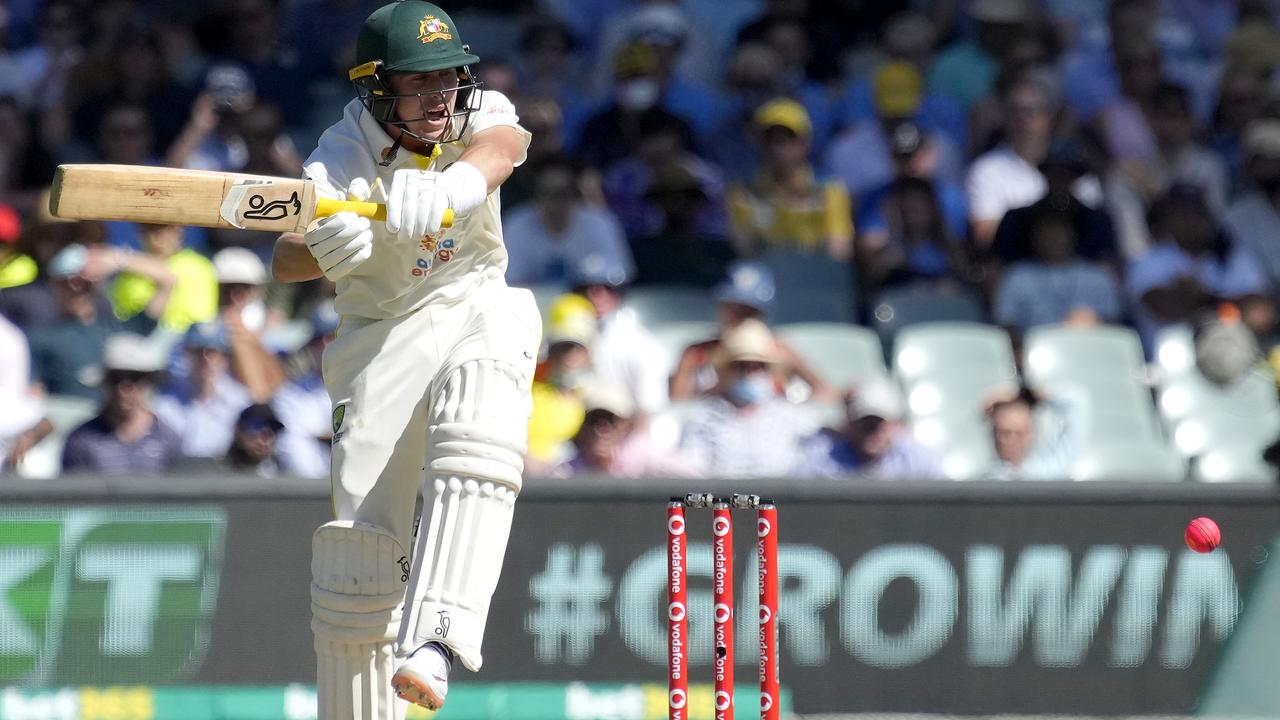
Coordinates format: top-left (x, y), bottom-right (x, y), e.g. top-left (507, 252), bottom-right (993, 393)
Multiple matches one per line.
top-left (303, 90), bottom-right (530, 320)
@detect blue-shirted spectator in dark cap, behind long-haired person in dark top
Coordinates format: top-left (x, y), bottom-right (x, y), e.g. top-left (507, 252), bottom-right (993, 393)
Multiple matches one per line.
top-left (854, 122), bottom-right (969, 254)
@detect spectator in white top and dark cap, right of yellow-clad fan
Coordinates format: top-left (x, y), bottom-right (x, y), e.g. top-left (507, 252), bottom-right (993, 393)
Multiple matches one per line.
top-left (573, 260), bottom-right (667, 421)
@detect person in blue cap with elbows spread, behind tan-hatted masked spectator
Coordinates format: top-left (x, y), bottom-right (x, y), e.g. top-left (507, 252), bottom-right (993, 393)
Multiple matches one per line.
top-left (669, 260), bottom-right (833, 401)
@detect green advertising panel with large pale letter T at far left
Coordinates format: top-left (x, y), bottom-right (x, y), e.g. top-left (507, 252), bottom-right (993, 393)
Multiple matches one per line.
top-left (0, 506), bottom-right (227, 684)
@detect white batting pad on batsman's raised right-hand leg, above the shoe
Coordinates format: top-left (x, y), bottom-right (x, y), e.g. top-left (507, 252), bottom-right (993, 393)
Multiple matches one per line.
top-left (397, 360), bottom-right (529, 670)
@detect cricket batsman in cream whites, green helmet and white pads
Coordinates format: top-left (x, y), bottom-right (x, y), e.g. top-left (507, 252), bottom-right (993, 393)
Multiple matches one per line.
top-left (273, 0), bottom-right (541, 720)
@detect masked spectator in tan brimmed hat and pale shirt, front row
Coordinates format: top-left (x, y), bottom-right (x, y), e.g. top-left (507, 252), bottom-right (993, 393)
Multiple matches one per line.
top-left (680, 319), bottom-right (815, 478)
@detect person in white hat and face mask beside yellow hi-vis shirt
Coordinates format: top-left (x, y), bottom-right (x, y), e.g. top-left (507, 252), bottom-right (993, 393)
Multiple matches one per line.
top-left (212, 247), bottom-right (285, 402)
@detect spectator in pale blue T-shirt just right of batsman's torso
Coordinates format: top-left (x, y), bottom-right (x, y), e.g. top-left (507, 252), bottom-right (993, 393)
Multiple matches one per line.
top-left (503, 158), bottom-right (635, 284)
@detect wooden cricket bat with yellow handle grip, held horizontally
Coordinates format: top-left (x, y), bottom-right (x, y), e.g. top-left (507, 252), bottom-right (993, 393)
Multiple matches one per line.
top-left (49, 164), bottom-right (453, 232)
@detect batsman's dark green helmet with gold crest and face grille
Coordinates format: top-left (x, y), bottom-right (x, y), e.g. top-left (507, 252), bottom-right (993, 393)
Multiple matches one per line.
top-left (348, 0), bottom-right (481, 143)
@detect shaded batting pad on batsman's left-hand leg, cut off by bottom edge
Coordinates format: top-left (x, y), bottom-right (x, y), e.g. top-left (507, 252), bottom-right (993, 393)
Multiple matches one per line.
top-left (311, 521), bottom-right (408, 720)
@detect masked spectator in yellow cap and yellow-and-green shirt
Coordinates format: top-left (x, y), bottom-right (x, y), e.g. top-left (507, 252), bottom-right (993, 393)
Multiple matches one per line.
top-left (728, 97), bottom-right (854, 259)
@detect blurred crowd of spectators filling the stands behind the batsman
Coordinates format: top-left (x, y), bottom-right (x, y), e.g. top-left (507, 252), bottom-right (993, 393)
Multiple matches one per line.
top-left (0, 0), bottom-right (1280, 479)
